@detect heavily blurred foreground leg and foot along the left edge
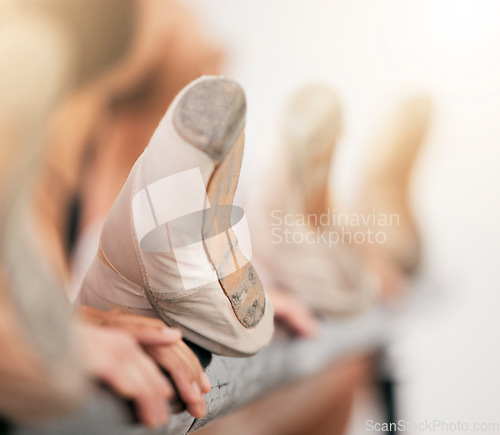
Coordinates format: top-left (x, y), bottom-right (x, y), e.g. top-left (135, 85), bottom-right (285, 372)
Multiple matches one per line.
top-left (0, 0), bottom-right (133, 422)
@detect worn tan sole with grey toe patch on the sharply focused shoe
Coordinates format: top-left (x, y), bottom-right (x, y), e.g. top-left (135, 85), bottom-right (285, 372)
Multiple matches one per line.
top-left (174, 80), bottom-right (266, 327)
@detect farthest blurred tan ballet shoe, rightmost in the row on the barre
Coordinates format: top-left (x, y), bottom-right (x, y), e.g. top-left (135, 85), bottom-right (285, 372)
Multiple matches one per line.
top-left (355, 95), bottom-right (432, 275)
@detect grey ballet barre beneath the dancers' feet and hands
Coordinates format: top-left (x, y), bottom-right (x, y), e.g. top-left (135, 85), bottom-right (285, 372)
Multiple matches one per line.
top-left (11, 307), bottom-right (391, 435)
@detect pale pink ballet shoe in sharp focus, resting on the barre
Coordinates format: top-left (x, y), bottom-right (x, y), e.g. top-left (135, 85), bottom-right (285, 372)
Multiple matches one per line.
top-left (80, 77), bottom-right (273, 356)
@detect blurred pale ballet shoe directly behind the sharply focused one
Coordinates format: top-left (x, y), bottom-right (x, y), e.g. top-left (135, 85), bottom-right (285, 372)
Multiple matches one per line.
top-left (245, 84), bottom-right (378, 317)
